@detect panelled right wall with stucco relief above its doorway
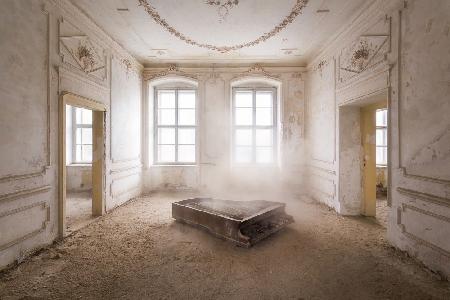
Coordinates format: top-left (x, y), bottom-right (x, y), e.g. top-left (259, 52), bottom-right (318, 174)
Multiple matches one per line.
top-left (306, 0), bottom-right (450, 276)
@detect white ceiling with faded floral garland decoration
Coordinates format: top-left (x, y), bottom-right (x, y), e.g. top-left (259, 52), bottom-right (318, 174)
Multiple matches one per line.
top-left (71, 0), bottom-right (371, 66)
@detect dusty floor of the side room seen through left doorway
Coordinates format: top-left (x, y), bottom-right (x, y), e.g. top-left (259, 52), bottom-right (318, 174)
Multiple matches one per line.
top-left (66, 191), bottom-right (93, 234)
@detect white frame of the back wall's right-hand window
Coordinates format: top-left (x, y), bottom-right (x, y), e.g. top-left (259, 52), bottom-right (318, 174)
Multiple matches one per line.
top-left (231, 87), bottom-right (278, 167)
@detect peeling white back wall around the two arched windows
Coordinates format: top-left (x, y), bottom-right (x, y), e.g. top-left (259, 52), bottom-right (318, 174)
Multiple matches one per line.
top-left (144, 67), bottom-right (304, 193)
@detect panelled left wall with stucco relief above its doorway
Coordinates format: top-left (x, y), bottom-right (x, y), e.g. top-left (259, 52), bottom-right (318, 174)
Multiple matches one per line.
top-left (0, 0), bottom-right (142, 268)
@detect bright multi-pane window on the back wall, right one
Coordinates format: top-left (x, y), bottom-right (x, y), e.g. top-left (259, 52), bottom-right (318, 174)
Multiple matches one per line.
top-left (233, 88), bottom-right (277, 164)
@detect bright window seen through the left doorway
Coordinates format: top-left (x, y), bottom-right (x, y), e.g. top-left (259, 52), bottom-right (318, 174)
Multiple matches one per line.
top-left (72, 107), bottom-right (92, 163)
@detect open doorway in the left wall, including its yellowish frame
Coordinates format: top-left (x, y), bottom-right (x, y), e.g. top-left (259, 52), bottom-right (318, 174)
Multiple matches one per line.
top-left (58, 93), bottom-right (106, 238)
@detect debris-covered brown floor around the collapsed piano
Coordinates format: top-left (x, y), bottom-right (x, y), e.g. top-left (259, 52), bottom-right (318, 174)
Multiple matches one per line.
top-left (0, 194), bottom-right (450, 299)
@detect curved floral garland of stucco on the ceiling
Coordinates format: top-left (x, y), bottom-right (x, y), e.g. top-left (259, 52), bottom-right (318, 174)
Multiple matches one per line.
top-left (138, 0), bottom-right (309, 53)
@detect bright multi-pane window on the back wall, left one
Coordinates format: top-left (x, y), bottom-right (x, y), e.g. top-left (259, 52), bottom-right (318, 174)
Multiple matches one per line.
top-left (154, 89), bottom-right (197, 164)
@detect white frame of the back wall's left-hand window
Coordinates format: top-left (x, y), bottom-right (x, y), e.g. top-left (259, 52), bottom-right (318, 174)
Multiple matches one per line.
top-left (153, 87), bottom-right (198, 166)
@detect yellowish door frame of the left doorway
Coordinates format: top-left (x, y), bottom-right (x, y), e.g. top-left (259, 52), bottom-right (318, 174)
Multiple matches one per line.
top-left (58, 92), bottom-right (106, 238)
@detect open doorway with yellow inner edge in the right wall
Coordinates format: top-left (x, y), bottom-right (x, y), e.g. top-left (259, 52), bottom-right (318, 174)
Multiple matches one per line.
top-left (339, 91), bottom-right (390, 227)
